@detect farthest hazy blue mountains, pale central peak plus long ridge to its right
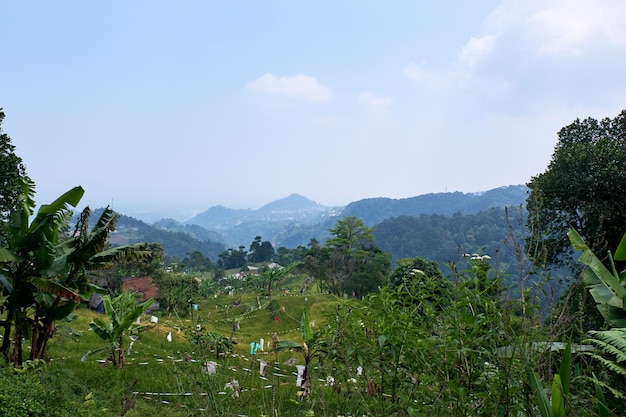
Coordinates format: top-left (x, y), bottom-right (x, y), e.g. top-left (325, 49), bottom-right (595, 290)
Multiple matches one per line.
top-left (180, 185), bottom-right (528, 248)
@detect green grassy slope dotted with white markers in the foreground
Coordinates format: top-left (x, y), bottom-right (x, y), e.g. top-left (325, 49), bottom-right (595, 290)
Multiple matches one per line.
top-left (9, 294), bottom-right (353, 417)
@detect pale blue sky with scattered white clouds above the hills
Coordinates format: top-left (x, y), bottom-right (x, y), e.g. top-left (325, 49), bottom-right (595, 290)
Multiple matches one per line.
top-left (0, 0), bottom-right (626, 220)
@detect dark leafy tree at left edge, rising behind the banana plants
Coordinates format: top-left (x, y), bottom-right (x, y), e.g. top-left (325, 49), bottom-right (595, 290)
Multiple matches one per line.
top-left (0, 108), bottom-right (26, 244)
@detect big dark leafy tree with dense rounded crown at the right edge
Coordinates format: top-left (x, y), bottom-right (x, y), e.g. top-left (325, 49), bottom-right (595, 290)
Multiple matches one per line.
top-left (527, 110), bottom-right (626, 264)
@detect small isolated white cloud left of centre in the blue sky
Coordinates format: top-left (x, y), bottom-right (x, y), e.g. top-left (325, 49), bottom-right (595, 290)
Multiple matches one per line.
top-left (247, 73), bottom-right (332, 102)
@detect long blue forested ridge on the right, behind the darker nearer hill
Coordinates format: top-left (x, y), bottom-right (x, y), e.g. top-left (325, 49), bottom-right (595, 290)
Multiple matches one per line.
top-left (341, 185), bottom-right (528, 227)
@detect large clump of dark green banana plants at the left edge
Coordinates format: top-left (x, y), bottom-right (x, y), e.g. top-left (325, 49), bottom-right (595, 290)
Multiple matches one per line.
top-left (0, 178), bottom-right (150, 366)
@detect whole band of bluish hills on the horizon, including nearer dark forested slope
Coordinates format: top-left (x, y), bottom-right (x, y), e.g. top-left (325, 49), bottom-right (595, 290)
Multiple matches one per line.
top-left (92, 186), bottom-right (527, 263)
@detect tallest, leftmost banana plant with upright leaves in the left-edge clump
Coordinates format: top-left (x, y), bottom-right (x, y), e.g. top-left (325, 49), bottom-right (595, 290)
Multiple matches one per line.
top-left (0, 178), bottom-right (84, 366)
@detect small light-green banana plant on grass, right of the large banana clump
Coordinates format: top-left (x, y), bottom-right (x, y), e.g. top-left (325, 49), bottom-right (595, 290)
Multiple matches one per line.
top-left (82, 291), bottom-right (153, 368)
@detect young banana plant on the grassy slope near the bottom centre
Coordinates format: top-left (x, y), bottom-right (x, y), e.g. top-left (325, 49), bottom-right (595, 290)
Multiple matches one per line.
top-left (273, 308), bottom-right (327, 397)
